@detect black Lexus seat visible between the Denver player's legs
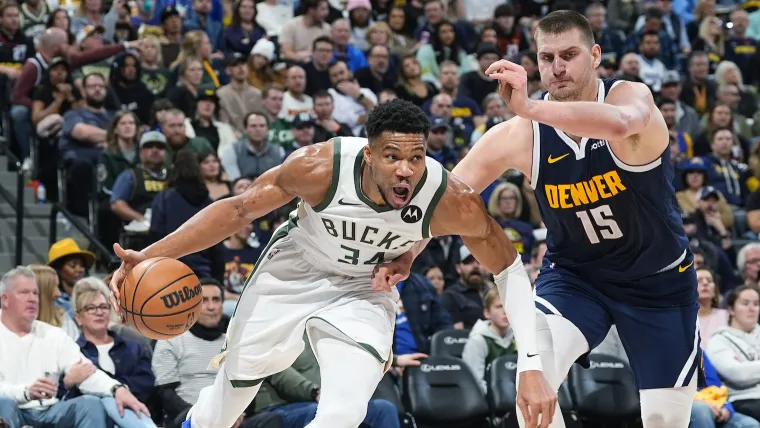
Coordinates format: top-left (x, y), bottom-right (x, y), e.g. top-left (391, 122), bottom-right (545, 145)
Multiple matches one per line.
top-left (570, 354), bottom-right (641, 423)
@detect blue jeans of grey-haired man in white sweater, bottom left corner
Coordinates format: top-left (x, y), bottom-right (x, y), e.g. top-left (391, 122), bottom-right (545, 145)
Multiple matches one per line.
top-left (0, 395), bottom-right (107, 428)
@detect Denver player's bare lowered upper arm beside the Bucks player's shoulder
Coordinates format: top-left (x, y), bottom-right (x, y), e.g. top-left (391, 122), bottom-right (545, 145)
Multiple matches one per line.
top-left (452, 117), bottom-right (533, 193)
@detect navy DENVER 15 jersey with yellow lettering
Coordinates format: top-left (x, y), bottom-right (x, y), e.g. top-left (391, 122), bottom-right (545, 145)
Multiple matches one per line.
top-left (531, 79), bottom-right (695, 304)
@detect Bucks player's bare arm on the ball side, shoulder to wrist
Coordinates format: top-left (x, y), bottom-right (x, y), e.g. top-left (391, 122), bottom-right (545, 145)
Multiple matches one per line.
top-left (143, 143), bottom-right (332, 258)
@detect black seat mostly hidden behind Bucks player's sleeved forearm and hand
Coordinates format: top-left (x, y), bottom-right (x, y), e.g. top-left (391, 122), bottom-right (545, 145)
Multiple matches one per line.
top-left (486, 355), bottom-right (577, 426)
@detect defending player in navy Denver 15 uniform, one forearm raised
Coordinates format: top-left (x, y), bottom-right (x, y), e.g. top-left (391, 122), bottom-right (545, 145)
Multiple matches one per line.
top-left (374, 10), bottom-right (701, 428)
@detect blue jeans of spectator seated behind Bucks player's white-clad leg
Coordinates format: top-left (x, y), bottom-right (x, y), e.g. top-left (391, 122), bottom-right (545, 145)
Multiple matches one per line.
top-left (264, 400), bottom-right (400, 428)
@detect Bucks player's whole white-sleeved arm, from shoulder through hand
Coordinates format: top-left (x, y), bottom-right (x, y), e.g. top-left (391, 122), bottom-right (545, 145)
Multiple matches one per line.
top-left (430, 175), bottom-right (557, 427)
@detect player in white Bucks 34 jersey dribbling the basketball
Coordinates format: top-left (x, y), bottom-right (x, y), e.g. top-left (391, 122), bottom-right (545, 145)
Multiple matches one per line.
top-left (111, 100), bottom-right (556, 428)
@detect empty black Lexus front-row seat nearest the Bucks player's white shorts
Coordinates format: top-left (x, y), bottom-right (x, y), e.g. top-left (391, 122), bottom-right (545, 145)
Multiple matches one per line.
top-left (403, 356), bottom-right (489, 428)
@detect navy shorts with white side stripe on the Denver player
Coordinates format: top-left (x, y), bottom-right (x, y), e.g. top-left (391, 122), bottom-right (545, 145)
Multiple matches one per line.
top-left (535, 261), bottom-right (704, 389)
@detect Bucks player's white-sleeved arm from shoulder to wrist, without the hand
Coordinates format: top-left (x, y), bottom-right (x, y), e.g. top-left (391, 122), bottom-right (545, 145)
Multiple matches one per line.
top-left (430, 175), bottom-right (542, 372)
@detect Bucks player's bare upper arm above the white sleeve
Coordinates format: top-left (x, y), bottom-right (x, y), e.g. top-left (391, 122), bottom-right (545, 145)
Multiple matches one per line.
top-left (430, 174), bottom-right (517, 274)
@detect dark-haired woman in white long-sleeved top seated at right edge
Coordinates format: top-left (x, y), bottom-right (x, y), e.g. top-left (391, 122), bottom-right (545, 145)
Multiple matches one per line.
top-left (707, 285), bottom-right (760, 419)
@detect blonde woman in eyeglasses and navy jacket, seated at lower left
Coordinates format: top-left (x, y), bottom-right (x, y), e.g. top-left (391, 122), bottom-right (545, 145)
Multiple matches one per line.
top-left (64, 277), bottom-right (156, 428)
